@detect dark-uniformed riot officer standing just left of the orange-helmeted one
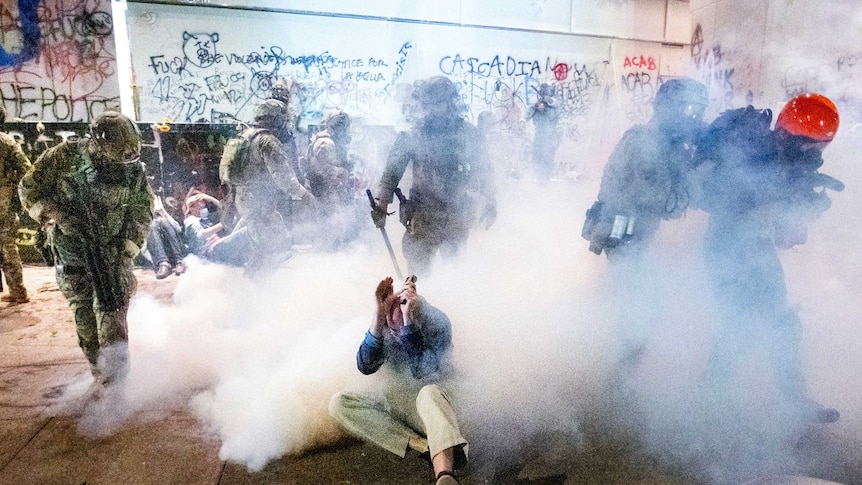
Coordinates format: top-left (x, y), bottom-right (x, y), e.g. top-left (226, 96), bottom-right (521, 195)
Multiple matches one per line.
top-left (582, 78), bottom-right (708, 370)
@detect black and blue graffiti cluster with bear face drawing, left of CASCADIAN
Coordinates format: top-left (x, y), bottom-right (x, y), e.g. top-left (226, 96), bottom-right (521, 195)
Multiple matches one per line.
top-left (141, 32), bottom-right (413, 123)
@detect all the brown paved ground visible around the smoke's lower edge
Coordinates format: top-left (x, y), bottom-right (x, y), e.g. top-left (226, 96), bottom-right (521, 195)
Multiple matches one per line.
top-left (0, 265), bottom-right (862, 485)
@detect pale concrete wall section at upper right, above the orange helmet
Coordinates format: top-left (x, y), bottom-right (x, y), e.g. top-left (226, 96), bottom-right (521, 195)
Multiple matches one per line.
top-left (691, 0), bottom-right (862, 124)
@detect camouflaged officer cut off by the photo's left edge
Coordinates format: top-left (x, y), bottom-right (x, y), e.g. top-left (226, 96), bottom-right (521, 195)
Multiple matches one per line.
top-left (0, 104), bottom-right (30, 305)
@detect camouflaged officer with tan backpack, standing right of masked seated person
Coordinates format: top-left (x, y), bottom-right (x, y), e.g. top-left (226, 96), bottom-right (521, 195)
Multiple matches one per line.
top-left (233, 99), bottom-right (314, 269)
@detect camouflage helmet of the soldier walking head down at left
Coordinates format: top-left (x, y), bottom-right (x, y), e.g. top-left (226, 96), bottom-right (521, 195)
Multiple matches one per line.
top-left (90, 111), bottom-right (141, 163)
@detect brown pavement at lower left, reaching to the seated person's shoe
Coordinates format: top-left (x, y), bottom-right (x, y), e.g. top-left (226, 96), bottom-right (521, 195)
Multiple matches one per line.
top-left (0, 266), bottom-right (446, 485)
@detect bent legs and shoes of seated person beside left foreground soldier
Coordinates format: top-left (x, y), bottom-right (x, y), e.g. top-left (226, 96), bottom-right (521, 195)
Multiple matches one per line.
top-left (146, 197), bottom-right (186, 280)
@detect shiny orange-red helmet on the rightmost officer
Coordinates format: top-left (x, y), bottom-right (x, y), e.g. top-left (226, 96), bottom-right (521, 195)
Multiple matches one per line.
top-left (775, 93), bottom-right (838, 142)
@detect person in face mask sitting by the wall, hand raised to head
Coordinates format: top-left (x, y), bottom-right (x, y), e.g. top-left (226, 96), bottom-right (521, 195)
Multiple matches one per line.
top-left (184, 192), bottom-right (251, 266)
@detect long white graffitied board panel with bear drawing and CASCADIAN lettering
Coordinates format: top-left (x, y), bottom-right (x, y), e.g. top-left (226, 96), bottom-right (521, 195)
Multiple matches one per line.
top-left (128, 4), bottom-right (628, 130)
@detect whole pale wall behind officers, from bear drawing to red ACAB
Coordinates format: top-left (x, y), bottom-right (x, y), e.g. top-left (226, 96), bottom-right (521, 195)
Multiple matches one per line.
top-left (121, 0), bottom-right (691, 177)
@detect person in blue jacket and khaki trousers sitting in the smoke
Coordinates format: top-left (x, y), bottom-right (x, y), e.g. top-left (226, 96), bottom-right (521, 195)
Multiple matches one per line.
top-left (329, 277), bottom-right (468, 485)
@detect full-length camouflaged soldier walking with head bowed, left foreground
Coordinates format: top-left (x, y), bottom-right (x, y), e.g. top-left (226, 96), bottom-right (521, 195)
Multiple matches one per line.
top-left (20, 111), bottom-right (153, 384)
